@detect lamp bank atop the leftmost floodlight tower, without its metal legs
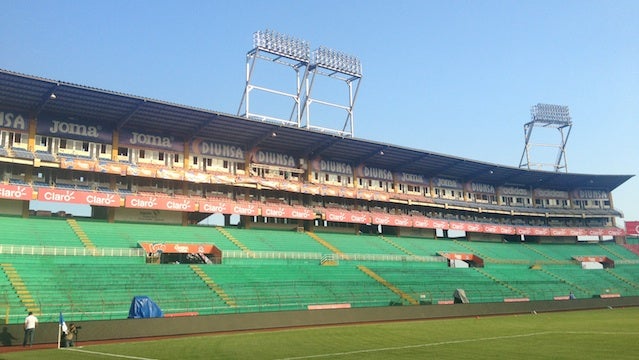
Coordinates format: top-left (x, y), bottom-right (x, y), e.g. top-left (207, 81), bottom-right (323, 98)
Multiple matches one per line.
top-left (253, 30), bottom-right (311, 63)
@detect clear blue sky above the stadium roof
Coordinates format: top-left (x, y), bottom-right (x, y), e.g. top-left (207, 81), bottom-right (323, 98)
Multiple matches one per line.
top-left (0, 0), bottom-right (639, 225)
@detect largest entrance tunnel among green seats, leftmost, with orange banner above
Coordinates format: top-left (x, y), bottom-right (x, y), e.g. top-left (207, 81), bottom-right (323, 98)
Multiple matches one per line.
top-left (139, 242), bottom-right (222, 264)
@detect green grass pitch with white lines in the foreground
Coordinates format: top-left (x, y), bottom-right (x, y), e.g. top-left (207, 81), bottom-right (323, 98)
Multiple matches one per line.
top-left (0, 307), bottom-right (639, 360)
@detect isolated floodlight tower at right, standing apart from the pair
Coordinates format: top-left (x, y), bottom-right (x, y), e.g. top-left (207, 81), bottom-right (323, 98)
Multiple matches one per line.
top-left (519, 104), bottom-right (572, 172)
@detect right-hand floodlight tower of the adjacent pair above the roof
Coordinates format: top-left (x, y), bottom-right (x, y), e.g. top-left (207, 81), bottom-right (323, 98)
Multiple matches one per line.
top-left (302, 46), bottom-right (362, 137)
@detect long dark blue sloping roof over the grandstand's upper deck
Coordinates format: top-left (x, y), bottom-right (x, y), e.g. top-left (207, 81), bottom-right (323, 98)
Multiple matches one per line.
top-left (0, 69), bottom-right (633, 191)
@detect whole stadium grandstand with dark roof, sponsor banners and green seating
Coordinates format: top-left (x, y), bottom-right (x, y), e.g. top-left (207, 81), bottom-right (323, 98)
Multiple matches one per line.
top-left (0, 62), bottom-right (639, 334)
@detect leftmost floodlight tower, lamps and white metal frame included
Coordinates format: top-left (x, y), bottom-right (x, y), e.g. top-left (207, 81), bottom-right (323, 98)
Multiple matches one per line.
top-left (237, 30), bottom-right (311, 127)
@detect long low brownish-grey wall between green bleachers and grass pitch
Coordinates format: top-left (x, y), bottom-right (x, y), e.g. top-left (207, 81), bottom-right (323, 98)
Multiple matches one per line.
top-left (3, 296), bottom-right (639, 346)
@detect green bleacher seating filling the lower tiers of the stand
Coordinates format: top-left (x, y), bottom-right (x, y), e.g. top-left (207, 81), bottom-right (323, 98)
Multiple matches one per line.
top-left (0, 216), bottom-right (639, 323)
